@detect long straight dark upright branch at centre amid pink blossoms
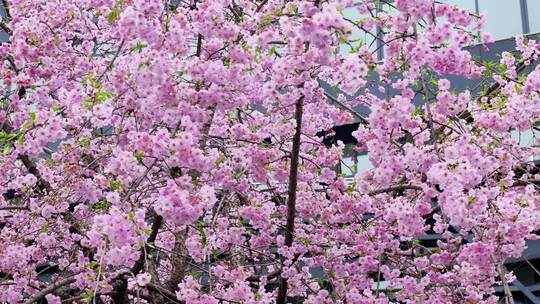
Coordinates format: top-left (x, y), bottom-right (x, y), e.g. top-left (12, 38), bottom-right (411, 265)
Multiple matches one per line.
top-left (276, 96), bottom-right (304, 304)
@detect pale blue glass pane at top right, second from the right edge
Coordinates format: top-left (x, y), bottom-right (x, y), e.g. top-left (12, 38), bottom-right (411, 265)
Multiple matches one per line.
top-left (478, 0), bottom-right (524, 40)
